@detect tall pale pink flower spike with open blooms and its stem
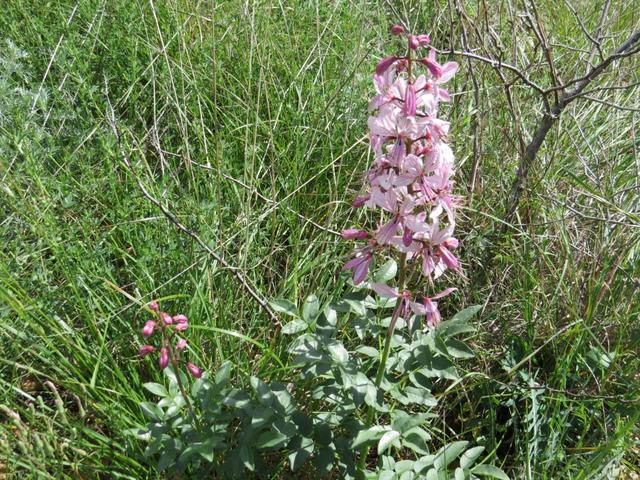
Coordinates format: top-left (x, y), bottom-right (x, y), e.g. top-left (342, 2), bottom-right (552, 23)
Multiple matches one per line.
top-left (342, 25), bottom-right (459, 470)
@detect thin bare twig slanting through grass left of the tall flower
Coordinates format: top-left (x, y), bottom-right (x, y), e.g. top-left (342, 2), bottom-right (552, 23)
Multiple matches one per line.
top-left (107, 85), bottom-right (281, 327)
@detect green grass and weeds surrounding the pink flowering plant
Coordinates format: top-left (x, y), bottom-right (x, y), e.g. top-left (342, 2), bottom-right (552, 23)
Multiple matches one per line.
top-left (0, 0), bottom-right (640, 479)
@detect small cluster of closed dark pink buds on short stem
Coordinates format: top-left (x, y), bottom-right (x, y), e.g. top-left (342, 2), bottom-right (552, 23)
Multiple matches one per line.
top-left (138, 300), bottom-right (202, 378)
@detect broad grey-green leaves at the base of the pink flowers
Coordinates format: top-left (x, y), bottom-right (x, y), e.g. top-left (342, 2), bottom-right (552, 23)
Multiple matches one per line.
top-left (133, 290), bottom-right (505, 479)
